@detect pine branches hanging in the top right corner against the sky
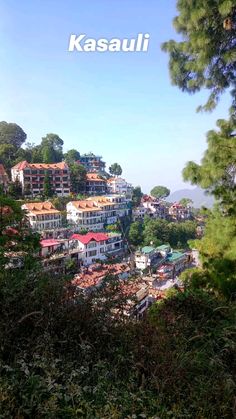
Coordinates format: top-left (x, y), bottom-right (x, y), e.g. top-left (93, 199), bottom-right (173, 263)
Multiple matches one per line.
top-left (162, 0), bottom-right (236, 112)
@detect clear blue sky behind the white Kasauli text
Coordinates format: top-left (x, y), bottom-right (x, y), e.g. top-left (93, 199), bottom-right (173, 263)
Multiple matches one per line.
top-left (0, 0), bottom-right (229, 192)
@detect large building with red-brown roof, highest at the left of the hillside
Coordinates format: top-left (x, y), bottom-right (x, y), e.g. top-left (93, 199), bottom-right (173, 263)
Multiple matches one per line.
top-left (11, 161), bottom-right (70, 196)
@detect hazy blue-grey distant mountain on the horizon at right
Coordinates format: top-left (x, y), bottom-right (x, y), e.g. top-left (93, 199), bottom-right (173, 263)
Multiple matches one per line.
top-left (166, 188), bottom-right (214, 208)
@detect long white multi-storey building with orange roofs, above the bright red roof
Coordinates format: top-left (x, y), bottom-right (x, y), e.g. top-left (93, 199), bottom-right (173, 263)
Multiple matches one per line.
top-left (66, 195), bottom-right (129, 231)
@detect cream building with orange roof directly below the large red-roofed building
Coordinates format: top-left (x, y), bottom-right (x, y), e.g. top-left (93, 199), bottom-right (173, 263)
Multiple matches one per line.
top-left (22, 201), bottom-right (61, 232)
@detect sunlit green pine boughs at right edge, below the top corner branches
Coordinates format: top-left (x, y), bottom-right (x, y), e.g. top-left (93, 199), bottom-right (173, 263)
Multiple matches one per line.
top-left (183, 118), bottom-right (236, 212)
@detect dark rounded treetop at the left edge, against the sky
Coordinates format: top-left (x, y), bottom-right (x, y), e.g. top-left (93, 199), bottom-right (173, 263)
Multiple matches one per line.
top-left (0, 121), bottom-right (27, 150)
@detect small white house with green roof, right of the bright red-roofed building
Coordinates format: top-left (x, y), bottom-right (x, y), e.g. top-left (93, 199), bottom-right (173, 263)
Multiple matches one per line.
top-left (134, 246), bottom-right (163, 270)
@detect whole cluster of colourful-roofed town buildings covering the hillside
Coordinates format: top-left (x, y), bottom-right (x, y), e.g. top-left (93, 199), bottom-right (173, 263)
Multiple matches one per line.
top-left (0, 153), bottom-right (204, 318)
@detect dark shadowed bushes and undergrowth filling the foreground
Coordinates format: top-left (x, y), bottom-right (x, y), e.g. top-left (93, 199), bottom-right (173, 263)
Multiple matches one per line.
top-left (0, 272), bottom-right (236, 419)
